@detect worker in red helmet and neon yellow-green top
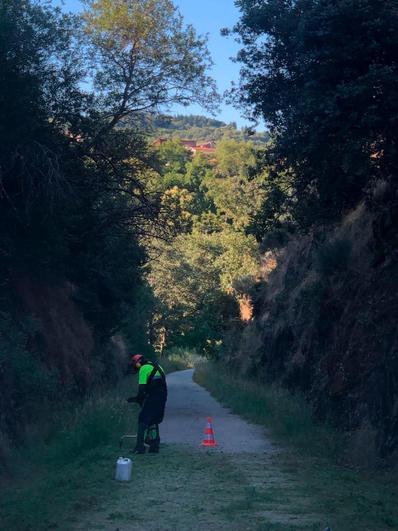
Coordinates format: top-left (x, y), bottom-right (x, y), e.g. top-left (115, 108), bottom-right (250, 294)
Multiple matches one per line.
top-left (127, 354), bottom-right (167, 454)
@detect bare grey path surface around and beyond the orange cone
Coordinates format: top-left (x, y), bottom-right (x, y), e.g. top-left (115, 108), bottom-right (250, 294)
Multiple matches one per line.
top-left (160, 369), bottom-right (274, 453)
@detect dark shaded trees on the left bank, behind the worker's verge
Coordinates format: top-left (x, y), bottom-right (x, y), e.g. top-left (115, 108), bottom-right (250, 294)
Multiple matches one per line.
top-left (0, 0), bottom-right (158, 437)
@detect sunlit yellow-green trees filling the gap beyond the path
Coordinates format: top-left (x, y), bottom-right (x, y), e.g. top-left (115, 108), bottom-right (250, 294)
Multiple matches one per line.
top-left (146, 138), bottom-right (266, 356)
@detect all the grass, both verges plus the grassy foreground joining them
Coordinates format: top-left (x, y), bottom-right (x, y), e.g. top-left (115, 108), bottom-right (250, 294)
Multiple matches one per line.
top-left (0, 358), bottom-right (398, 531)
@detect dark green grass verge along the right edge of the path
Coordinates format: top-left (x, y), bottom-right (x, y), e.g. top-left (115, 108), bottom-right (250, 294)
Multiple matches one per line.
top-left (194, 364), bottom-right (398, 531)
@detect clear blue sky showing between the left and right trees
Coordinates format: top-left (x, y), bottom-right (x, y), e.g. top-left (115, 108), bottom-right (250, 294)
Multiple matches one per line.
top-left (56, 0), bottom-right (258, 127)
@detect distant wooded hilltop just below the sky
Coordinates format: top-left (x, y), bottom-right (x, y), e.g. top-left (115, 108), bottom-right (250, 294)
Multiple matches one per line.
top-left (151, 114), bottom-right (269, 144)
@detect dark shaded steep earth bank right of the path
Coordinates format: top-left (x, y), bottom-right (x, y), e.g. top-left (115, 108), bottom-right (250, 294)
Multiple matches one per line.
top-left (224, 202), bottom-right (398, 465)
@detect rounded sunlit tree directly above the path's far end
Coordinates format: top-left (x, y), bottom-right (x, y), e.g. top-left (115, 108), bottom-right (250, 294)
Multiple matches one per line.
top-left (148, 229), bottom-right (252, 355)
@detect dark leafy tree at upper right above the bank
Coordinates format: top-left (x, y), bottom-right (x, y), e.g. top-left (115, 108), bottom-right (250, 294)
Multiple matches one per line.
top-left (229, 0), bottom-right (398, 227)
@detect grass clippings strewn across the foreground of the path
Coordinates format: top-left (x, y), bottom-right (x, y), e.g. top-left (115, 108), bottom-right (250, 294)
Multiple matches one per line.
top-left (67, 445), bottom-right (323, 531)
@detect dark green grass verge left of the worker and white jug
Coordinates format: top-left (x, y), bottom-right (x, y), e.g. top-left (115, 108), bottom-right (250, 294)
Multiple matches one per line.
top-left (0, 379), bottom-right (138, 531)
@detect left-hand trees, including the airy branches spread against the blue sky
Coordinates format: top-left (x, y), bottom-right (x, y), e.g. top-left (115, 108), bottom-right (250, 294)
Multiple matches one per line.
top-left (0, 0), bottom-right (217, 436)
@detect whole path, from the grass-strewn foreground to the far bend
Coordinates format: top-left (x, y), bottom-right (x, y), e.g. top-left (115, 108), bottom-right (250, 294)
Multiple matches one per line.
top-left (71, 370), bottom-right (324, 531)
